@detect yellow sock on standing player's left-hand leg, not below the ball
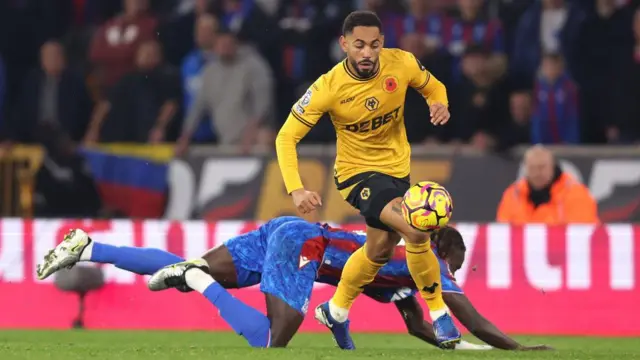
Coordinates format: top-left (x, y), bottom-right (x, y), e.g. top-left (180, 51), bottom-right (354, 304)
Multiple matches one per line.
top-left (331, 244), bottom-right (384, 310)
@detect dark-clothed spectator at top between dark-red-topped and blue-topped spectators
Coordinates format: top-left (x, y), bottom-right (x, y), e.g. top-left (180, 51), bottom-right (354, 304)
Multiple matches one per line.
top-left (158, 0), bottom-right (217, 66)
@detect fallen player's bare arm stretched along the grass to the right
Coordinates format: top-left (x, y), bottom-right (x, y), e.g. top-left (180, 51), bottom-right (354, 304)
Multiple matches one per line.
top-left (442, 292), bottom-right (525, 350)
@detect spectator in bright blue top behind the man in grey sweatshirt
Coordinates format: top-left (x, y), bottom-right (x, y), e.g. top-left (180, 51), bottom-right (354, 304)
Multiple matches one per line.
top-left (181, 14), bottom-right (218, 142)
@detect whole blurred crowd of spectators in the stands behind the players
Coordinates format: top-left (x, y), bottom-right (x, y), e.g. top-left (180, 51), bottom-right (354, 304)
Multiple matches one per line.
top-left (0, 0), bottom-right (640, 152)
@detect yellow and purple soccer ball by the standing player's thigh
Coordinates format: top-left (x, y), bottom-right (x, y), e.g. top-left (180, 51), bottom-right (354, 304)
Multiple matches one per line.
top-left (401, 181), bottom-right (453, 231)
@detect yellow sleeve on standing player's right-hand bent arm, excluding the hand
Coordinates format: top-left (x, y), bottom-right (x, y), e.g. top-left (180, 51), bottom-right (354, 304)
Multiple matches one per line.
top-left (405, 52), bottom-right (449, 106)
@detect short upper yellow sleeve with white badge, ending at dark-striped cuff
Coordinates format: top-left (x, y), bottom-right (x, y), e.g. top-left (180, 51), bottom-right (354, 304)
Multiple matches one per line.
top-left (291, 75), bottom-right (332, 127)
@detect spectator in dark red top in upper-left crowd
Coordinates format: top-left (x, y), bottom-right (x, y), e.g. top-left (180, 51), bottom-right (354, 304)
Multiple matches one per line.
top-left (89, 0), bottom-right (157, 94)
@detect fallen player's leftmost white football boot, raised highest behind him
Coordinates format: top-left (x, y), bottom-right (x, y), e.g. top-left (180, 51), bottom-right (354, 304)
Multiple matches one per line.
top-left (36, 229), bottom-right (91, 280)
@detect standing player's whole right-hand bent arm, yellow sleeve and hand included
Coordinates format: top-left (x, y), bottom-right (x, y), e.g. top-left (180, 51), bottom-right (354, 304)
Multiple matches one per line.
top-left (405, 53), bottom-right (450, 125)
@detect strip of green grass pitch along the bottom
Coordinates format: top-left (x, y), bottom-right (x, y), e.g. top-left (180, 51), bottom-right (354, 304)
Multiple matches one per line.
top-left (0, 331), bottom-right (640, 360)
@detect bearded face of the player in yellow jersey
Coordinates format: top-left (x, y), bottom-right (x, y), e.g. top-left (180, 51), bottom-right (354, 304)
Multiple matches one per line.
top-left (340, 26), bottom-right (384, 78)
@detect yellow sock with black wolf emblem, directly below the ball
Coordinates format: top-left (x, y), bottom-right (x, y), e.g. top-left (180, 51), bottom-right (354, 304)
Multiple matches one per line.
top-left (405, 241), bottom-right (447, 311)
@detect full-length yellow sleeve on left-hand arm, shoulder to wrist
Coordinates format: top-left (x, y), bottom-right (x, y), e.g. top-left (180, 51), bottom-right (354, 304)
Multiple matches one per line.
top-left (276, 76), bottom-right (331, 194)
